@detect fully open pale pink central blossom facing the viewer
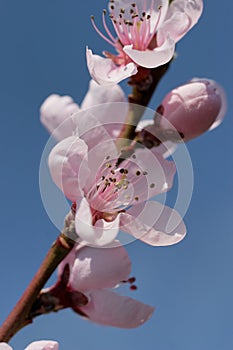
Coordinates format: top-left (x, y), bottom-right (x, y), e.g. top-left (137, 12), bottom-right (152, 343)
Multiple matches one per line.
top-left (49, 104), bottom-right (186, 246)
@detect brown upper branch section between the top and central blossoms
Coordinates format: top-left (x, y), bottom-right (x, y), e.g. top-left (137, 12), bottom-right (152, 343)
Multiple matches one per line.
top-left (116, 62), bottom-right (170, 151)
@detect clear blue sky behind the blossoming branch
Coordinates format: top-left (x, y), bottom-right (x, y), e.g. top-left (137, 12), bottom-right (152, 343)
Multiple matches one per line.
top-left (0, 0), bottom-right (233, 350)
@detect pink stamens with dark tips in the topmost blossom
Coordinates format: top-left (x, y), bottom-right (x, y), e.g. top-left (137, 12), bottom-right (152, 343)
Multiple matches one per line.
top-left (91, 0), bottom-right (162, 56)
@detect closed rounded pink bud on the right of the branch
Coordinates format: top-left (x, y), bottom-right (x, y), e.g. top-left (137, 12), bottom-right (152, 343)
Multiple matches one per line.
top-left (159, 78), bottom-right (226, 141)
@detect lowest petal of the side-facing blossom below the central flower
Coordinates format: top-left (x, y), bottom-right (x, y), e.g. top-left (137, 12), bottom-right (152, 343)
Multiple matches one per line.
top-left (80, 290), bottom-right (154, 328)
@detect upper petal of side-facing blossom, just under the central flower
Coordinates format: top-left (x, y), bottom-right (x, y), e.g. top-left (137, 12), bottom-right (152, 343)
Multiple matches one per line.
top-left (68, 243), bottom-right (131, 292)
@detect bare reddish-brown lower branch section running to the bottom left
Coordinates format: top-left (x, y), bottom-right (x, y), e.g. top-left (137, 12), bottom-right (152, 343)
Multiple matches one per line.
top-left (0, 233), bottom-right (75, 342)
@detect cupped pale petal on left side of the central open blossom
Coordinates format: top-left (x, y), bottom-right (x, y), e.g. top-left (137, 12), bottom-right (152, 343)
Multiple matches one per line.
top-left (48, 136), bottom-right (89, 201)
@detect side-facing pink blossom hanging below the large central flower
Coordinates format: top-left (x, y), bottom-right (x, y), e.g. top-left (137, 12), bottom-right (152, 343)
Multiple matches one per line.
top-left (51, 242), bottom-right (154, 328)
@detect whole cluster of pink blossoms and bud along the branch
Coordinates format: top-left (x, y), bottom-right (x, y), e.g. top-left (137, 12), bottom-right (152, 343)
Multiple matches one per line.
top-left (0, 0), bottom-right (226, 350)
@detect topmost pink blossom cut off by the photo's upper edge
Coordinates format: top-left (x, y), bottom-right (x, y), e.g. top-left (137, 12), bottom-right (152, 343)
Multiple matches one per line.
top-left (86, 0), bottom-right (203, 85)
